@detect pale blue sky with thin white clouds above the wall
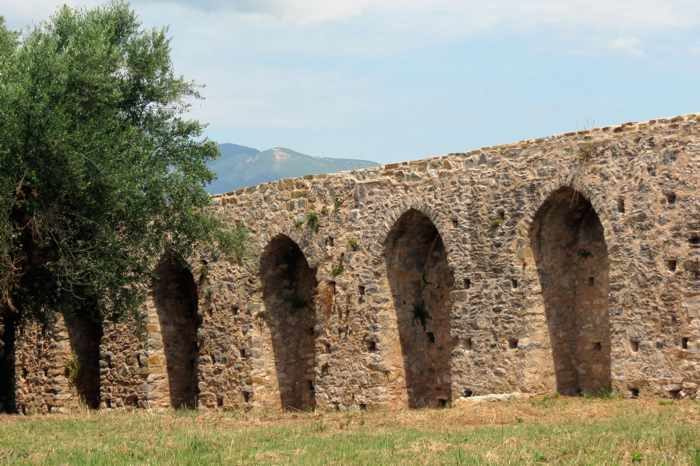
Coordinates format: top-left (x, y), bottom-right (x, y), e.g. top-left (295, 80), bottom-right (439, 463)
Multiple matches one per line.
top-left (5, 0), bottom-right (700, 162)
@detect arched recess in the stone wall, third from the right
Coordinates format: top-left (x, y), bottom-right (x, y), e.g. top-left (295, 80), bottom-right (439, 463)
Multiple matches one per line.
top-left (260, 235), bottom-right (317, 410)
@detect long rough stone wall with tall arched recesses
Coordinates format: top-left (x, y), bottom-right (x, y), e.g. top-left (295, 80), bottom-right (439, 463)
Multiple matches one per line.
top-left (5, 115), bottom-right (700, 409)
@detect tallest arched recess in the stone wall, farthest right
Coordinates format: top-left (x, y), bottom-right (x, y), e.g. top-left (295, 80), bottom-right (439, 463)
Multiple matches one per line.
top-left (530, 188), bottom-right (611, 395)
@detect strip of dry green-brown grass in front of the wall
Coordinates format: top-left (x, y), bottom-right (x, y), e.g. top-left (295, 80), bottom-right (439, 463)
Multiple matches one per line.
top-left (0, 397), bottom-right (700, 466)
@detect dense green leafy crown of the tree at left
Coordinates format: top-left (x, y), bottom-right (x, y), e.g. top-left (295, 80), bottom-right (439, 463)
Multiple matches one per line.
top-left (0, 2), bottom-right (226, 318)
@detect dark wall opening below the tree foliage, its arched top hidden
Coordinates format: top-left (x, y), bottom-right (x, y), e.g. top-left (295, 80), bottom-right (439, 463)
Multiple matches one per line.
top-left (64, 313), bottom-right (102, 409)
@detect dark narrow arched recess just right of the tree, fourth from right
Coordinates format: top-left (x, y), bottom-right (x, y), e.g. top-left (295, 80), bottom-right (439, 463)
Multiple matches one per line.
top-left (153, 254), bottom-right (200, 409)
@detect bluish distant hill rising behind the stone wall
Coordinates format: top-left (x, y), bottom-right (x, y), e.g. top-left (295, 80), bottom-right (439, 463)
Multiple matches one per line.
top-left (207, 144), bottom-right (378, 194)
